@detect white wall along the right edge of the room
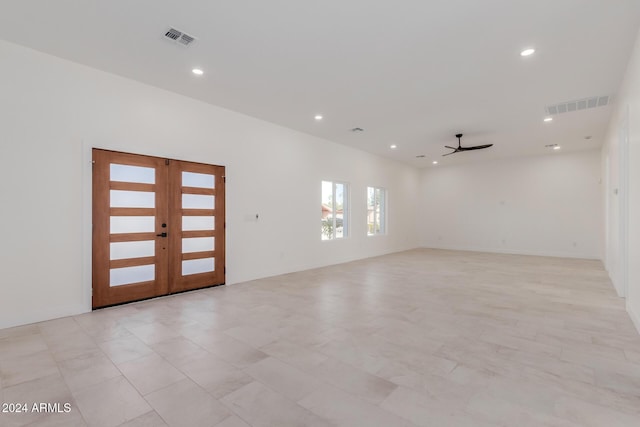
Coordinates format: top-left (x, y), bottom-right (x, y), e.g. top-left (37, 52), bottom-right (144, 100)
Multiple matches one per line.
top-left (602, 28), bottom-right (640, 331)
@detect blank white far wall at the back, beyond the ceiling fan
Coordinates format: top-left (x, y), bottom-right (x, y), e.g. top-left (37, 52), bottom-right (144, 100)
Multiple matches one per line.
top-left (418, 150), bottom-right (602, 258)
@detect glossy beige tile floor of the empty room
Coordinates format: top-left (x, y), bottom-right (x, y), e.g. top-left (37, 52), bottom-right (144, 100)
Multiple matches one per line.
top-left (0, 250), bottom-right (640, 427)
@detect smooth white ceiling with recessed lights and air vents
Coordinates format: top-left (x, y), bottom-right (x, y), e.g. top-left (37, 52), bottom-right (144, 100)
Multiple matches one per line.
top-left (0, 0), bottom-right (640, 167)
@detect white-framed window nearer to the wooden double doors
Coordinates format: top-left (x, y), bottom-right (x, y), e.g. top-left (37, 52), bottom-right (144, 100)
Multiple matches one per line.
top-left (321, 181), bottom-right (349, 240)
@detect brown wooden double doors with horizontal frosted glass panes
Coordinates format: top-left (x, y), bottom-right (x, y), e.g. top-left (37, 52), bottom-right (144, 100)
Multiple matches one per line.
top-left (93, 149), bottom-right (225, 308)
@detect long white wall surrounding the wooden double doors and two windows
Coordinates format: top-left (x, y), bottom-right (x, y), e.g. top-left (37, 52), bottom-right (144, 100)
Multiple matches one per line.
top-left (0, 41), bottom-right (419, 328)
